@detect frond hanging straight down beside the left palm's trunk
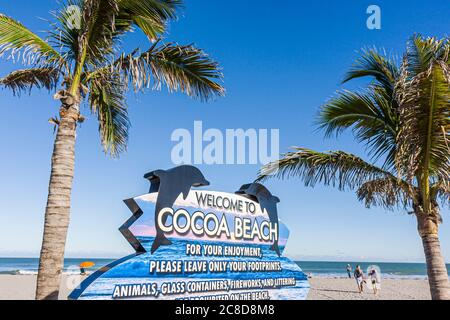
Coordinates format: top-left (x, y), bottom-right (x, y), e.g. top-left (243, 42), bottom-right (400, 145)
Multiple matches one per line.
top-left (88, 70), bottom-right (130, 157)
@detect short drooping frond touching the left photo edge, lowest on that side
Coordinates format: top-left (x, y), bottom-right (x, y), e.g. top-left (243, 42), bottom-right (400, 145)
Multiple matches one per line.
top-left (0, 68), bottom-right (60, 95)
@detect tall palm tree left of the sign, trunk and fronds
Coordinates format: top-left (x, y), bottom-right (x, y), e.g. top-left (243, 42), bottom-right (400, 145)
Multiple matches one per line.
top-left (0, 0), bottom-right (224, 299)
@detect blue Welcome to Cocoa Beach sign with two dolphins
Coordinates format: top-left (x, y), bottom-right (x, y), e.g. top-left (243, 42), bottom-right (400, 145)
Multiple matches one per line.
top-left (69, 166), bottom-right (309, 300)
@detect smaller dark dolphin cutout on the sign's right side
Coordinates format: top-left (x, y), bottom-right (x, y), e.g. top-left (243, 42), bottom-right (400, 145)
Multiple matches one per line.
top-left (235, 183), bottom-right (281, 256)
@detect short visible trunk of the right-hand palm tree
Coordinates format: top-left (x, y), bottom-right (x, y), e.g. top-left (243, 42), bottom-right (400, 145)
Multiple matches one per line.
top-left (416, 213), bottom-right (450, 300)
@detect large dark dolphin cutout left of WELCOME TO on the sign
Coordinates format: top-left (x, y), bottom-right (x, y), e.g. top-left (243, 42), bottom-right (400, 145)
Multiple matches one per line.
top-left (144, 165), bottom-right (209, 254)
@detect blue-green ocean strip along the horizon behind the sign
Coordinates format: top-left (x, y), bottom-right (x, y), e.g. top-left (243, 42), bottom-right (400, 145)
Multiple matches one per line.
top-left (0, 258), bottom-right (450, 279)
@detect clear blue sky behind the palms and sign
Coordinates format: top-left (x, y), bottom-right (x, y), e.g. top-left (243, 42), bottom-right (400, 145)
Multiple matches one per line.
top-left (0, 0), bottom-right (450, 261)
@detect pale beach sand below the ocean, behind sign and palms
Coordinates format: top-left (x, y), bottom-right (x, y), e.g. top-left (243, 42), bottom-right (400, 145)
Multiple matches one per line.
top-left (0, 275), bottom-right (431, 300)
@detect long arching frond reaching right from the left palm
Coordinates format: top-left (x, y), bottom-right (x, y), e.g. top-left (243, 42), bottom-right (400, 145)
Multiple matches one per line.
top-left (90, 43), bottom-right (225, 100)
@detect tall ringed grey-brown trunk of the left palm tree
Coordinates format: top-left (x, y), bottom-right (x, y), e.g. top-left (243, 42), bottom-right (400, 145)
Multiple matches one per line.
top-left (36, 105), bottom-right (79, 300)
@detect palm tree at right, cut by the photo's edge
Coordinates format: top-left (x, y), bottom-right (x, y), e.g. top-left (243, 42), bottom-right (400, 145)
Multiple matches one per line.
top-left (258, 36), bottom-right (450, 299)
